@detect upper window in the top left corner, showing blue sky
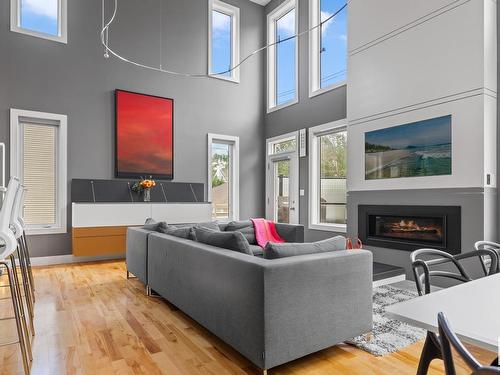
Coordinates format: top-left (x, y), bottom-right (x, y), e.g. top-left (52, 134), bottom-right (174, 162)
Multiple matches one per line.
top-left (10, 0), bottom-right (68, 43)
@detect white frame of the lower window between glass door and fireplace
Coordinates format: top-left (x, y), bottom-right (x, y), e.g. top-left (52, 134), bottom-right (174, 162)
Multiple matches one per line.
top-left (309, 119), bottom-right (349, 233)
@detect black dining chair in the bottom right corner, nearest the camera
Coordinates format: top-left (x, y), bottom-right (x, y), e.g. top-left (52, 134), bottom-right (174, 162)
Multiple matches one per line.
top-left (438, 312), bottom-right (500, 375)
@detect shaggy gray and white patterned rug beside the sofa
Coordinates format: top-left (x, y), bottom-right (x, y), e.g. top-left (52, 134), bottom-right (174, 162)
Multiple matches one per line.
top-left (349, 285), bottom-right (425, 356)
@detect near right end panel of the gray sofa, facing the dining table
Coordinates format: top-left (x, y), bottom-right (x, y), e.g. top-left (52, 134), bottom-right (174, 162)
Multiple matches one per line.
top-left (264, 250), bottom-right (373, 368)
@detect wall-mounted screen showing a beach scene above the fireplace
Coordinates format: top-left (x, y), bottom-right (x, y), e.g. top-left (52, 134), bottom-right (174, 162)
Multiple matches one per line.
top-left (365, 115), bottom-right (451, 180)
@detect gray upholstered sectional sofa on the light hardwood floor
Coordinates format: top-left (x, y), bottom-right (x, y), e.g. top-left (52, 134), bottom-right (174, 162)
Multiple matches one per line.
top-left (126, 224), bottom-right (372, 369)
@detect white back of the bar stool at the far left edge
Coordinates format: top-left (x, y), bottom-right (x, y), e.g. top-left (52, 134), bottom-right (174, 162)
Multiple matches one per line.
top-left (0, 177), bottom-right (19, 259)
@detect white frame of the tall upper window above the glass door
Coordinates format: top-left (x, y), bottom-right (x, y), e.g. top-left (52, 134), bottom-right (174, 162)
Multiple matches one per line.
top-left (267, 0), bottom-right (299, 113)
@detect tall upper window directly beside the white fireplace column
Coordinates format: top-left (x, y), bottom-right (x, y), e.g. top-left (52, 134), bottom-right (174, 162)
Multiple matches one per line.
top-left (309, 0), bottom-right (347, 96)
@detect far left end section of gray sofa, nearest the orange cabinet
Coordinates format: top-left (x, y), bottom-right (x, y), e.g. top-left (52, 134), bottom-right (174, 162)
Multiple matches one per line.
top-left (126, 228), bottom-right (153, 285)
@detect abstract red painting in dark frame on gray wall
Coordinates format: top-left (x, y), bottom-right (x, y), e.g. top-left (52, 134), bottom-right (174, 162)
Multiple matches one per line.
top-left (115, 90), bottom-right (174, 180)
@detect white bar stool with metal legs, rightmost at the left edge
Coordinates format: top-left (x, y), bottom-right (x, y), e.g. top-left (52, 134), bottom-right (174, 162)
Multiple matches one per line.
top-left (10, 185), bottom-right (35, 336)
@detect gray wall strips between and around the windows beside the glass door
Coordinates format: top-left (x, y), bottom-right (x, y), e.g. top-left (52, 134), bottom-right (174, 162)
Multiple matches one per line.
top-left (264, 0), bottom-right (347, 241)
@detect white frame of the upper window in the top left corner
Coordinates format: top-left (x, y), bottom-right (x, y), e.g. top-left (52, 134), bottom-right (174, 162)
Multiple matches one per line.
top-left (10, 0), bottom-right (68, 44)
